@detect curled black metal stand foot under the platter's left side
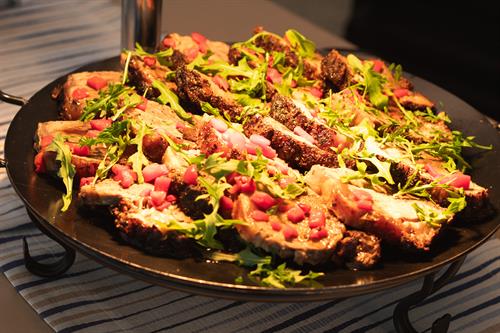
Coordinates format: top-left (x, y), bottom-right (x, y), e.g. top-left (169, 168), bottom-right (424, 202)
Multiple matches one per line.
top-left (23, 209), bottom-right (76, 277)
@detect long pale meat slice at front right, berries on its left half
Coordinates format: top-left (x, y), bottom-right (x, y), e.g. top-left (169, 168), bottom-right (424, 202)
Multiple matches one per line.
top-left (305, 166), bottom-right (451, 251)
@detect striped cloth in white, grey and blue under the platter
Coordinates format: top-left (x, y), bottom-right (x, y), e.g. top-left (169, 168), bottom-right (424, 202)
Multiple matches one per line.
top-left (0, 1), bottom-right (500, 333)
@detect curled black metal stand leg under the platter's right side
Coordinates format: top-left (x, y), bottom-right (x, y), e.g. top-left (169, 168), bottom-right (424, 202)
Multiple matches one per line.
top-left (393, 256), bottom-right (465, 333)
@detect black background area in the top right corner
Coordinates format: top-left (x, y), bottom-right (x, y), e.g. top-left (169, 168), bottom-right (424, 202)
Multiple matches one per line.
top-left (273, 0), bottom-right (500, 120)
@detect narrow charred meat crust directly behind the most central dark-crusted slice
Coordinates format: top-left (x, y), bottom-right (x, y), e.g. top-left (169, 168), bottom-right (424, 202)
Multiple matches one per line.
top-left (269, 94), bottom-right (336, 149)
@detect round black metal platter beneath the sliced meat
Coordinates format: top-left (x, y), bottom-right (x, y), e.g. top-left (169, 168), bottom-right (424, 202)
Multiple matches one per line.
top-left (5, 57), bottom-right (500, 302)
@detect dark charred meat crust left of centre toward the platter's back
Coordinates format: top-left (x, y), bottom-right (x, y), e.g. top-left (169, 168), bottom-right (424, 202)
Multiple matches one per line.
top-left (175, 67), bottom-right (243, 120)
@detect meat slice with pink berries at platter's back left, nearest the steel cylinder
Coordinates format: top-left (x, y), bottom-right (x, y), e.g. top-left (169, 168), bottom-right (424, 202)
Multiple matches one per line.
top-left (59, 72), bottom-right (122, 120)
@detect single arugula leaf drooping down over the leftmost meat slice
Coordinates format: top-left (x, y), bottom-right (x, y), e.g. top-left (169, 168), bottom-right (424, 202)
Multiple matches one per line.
top-left (47, 134), bottom-right (76, 212)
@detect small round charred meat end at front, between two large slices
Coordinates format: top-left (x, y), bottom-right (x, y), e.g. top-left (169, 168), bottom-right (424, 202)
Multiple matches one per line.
top-left (337, 230), bottom-right (382, 269)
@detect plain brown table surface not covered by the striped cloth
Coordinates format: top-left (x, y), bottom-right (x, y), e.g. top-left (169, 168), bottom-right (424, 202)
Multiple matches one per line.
top-left (0, 0), bottom-right (500, 333)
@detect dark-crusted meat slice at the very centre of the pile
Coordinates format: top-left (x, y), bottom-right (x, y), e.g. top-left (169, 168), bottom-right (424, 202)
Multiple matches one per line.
top-left (243, 115), bottom-right (338, 171)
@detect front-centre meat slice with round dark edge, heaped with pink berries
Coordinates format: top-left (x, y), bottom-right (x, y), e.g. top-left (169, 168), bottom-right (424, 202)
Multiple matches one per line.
top-left (233, 194), bottom-right (345, 265)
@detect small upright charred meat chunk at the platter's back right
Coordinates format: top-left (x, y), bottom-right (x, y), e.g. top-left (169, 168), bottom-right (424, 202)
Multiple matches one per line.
top-left (321, 50), bottom-right (353, 91)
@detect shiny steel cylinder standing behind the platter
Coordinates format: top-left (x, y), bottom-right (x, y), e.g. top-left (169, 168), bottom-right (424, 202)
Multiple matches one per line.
top-left (121, 0), bottom-right (162, 51)
